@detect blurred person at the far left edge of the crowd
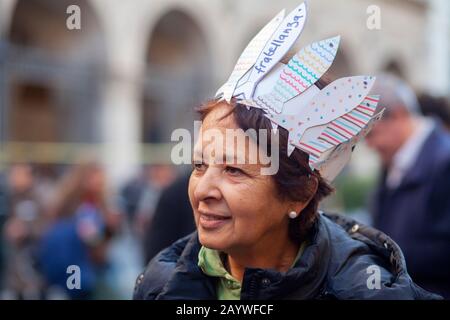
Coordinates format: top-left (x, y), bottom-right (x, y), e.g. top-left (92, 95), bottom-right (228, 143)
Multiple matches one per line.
top-left (2, 164), bottom-right (46, 299)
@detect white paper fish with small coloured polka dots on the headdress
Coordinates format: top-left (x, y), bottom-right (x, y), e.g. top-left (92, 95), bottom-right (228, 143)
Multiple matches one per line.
top-left (266, 76), bottom-right (375, 155)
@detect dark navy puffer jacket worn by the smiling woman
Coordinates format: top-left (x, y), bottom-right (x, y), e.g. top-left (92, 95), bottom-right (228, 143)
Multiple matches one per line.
top-left (134, 213), bottom-right (440, 300)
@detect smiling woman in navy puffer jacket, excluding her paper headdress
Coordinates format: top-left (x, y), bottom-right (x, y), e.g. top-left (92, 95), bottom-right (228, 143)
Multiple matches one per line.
top-left (135, 102), bottom-right (435, 300)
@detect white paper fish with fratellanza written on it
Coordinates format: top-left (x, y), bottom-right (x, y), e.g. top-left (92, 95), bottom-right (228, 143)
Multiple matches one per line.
top-left (233, 3), bottom-right (306, 99)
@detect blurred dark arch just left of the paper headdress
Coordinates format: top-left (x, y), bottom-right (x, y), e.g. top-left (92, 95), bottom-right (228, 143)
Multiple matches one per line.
top-left (142, 10), bottom-right (211, 143)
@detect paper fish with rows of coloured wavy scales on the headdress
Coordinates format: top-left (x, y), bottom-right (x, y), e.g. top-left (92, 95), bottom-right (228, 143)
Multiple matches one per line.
top-left (256, 36), bottom-right (340, 114)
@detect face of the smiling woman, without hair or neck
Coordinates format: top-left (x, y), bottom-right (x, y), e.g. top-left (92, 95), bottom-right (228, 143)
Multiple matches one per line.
top-left (189, 103), bottom-right (295, 253)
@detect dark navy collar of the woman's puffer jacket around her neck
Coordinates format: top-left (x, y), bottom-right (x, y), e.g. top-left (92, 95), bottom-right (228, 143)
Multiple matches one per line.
top-left (157, 216), bottom-right (330, 300)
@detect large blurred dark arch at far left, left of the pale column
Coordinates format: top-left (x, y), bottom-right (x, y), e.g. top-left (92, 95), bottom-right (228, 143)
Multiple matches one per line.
top-left (5, 0), bottom-right (106, 143)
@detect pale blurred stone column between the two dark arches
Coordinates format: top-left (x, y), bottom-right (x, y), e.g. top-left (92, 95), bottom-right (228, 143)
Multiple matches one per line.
top-left (95, 1), bottom-right (145, 186)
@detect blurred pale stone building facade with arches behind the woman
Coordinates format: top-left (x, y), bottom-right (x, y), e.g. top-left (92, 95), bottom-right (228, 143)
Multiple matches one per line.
top-left (0, 0), bottom-right (450, 183)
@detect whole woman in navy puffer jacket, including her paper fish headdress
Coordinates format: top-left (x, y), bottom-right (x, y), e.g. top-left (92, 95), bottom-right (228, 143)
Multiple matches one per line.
top-left (134, 6), bottom-right (439, 300)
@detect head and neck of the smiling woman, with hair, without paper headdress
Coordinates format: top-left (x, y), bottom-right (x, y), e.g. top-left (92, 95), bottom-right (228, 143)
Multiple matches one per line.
top-left (189, 101), bottom-right (332, 282)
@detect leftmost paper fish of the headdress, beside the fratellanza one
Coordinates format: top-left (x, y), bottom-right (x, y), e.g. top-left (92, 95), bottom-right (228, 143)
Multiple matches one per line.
top-left (216, 10), bottom-right (285, 102)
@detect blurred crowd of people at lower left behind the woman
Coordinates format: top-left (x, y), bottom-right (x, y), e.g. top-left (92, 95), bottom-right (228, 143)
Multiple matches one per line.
top-left (0, 162), bottom-right (183, 299)
